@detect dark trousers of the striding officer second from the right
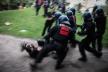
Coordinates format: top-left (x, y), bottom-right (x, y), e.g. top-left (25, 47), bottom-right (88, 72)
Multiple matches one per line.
top-left (79, 37), bottom-right (98, 58)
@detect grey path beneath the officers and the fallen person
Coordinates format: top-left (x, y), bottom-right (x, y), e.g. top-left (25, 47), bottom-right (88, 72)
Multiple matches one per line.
top-left (0, 35), bottom-right (108, 72)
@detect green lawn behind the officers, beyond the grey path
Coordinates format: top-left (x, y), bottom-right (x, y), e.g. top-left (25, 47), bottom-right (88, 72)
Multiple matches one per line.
top-left (0, 8), bottom-right (108, 47)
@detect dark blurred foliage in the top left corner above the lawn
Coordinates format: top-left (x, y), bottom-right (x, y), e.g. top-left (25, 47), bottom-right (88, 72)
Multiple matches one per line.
top-left (0, 0), bottom-right (34, 10)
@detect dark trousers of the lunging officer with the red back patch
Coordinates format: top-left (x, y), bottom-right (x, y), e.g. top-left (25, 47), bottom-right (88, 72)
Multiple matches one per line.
top-left (36, 42), bottom-right (68, 66)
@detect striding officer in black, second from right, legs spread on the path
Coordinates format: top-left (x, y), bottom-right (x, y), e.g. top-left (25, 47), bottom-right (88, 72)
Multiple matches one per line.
top-left (78, 12), bottom-right (102, 62)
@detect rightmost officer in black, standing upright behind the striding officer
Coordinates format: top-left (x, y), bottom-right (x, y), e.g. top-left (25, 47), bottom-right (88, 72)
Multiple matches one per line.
top-left (94, 8), bottom-right (106, 52)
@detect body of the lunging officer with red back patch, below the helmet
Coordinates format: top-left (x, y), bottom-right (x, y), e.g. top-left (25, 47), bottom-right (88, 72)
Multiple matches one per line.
top-left (31, 16), bottom-right (73, 69)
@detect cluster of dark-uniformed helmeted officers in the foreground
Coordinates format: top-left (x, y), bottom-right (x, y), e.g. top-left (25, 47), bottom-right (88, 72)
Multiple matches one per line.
top-left (23, 0), bottom-right (106, 69)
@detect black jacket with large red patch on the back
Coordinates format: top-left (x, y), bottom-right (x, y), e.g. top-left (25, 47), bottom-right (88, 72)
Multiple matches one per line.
top-left (45, 25), bottom-right (74, 44)
